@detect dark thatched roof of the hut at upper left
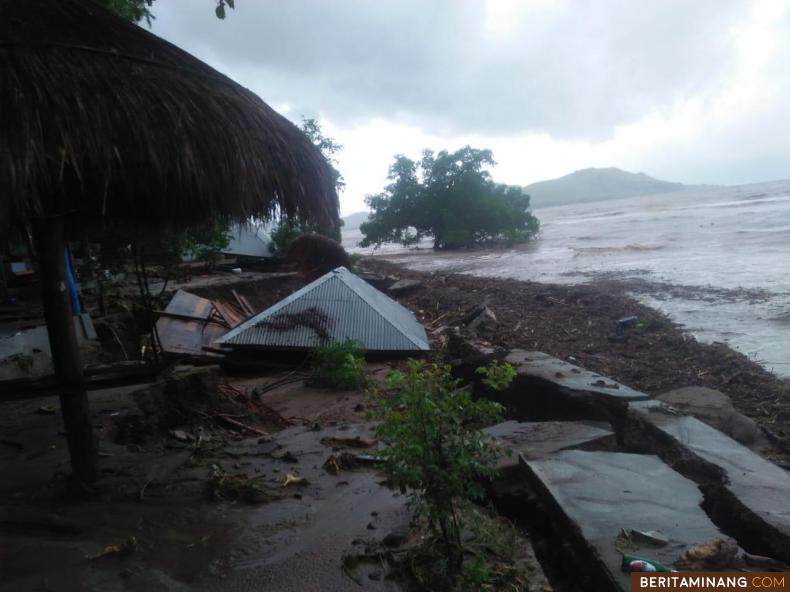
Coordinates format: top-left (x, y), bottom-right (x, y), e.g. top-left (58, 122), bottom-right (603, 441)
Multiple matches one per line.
top-left (0, 0), bottom-right (338, 236)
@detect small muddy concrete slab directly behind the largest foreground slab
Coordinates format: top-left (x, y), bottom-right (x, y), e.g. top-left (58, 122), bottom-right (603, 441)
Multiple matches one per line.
top-left (483, 420), bottom-right (614, 495)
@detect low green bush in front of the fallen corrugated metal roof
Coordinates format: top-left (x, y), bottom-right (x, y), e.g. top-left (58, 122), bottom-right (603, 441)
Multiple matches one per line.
top-left (311, 339), bottom-right (368, 391)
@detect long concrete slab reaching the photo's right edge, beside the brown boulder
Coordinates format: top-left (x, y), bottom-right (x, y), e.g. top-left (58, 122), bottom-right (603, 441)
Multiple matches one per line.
top-left (625, 401), bottom-right (790, 562)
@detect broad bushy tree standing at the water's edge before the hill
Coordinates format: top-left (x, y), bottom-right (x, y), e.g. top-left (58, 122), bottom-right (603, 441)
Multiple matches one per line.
top-left (360, 146), bottom-right (539, 249)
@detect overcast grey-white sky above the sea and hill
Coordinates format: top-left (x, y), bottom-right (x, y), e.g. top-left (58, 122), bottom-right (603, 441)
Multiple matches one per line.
top-left (153, 0), bottom-right (790, 215)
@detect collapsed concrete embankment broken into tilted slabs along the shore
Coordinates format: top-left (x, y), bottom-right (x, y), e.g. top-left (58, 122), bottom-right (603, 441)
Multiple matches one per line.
top-left (458, 340), bottom-right (790, 590)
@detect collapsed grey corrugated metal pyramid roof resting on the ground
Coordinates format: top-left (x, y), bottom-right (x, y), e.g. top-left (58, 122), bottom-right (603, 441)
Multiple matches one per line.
top-left (218, 267), bottom-right (430, 352)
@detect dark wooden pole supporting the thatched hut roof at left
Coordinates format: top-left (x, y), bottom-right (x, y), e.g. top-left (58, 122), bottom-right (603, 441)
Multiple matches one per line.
top-left (34, 218), bottom-right (99, 483)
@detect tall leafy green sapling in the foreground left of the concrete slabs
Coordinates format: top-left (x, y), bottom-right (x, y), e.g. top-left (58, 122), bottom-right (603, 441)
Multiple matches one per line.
top-left (373, 360), bottom-right (502, 579)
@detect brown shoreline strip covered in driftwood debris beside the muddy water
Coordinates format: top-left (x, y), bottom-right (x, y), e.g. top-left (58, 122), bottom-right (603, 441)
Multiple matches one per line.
top-left (362, 257), bottom-right (790, 463)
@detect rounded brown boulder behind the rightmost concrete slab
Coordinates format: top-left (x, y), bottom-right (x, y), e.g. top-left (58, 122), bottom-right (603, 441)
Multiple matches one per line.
top-left (656, 386), bottom-right (769, 450)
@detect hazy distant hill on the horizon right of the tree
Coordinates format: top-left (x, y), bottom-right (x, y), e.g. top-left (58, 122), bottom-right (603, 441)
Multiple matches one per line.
top-left (524, 167), bottom-right (699, 208)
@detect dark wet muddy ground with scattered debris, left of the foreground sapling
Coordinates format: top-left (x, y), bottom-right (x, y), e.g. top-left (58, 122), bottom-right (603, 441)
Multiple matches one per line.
top-left (0, 366), bottom-right (411, 592)
